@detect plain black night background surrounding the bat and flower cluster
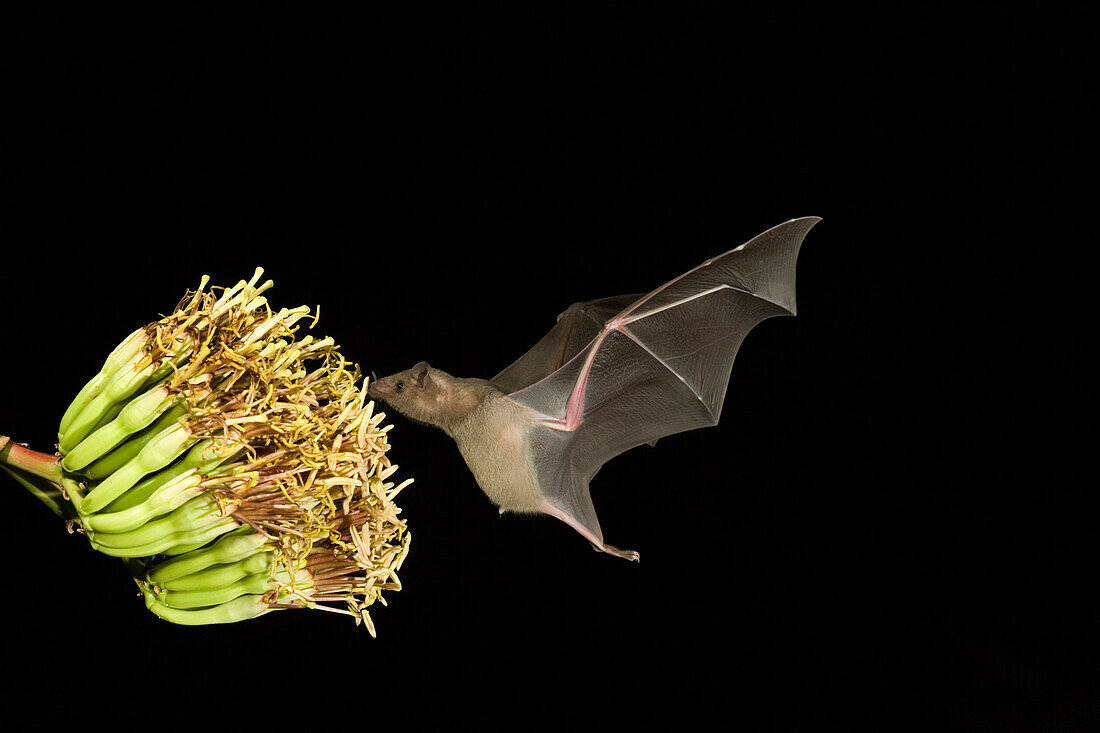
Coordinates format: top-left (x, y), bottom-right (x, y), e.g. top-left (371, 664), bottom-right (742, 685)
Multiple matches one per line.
top-left (0, 2), bottom-right (1086, 730)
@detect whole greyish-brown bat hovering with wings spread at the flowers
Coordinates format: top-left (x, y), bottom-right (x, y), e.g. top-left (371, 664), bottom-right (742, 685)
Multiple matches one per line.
top-left (369, 217), bottom-right (820, 560)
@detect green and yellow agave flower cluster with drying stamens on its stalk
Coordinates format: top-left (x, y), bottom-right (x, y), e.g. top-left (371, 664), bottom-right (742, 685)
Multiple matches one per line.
top-left (0, 269), bottom-right (411, 634)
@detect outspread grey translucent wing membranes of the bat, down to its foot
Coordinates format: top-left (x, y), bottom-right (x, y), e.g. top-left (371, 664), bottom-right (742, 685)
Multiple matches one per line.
top-left (498, 217), bottom-right (820, 559)
